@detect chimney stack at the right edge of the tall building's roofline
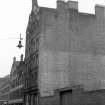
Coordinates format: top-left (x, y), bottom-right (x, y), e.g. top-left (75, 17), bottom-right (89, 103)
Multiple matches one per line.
top-left (95, 4), bottom-right (105, 19)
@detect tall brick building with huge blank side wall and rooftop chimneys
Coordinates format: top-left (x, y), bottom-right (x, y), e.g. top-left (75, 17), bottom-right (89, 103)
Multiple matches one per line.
top-left (24, 0), bottom-right (105, 105)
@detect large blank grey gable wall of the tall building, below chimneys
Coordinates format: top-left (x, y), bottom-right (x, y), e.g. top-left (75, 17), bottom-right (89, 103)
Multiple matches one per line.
top-left (39, 1), bottom-right (105, 96)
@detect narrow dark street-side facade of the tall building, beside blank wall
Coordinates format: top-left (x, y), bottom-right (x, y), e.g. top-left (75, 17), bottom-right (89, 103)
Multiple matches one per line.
top-left (24, 0), bottom-right (40, 105)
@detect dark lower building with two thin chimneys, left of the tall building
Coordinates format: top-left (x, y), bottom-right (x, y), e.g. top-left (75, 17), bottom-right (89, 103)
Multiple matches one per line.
top-left (8, 55), bottom-right (25, 105)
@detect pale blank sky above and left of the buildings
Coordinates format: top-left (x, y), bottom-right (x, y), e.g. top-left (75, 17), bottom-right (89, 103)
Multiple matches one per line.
top-left (0, 0), bottom-right (105, 77)
